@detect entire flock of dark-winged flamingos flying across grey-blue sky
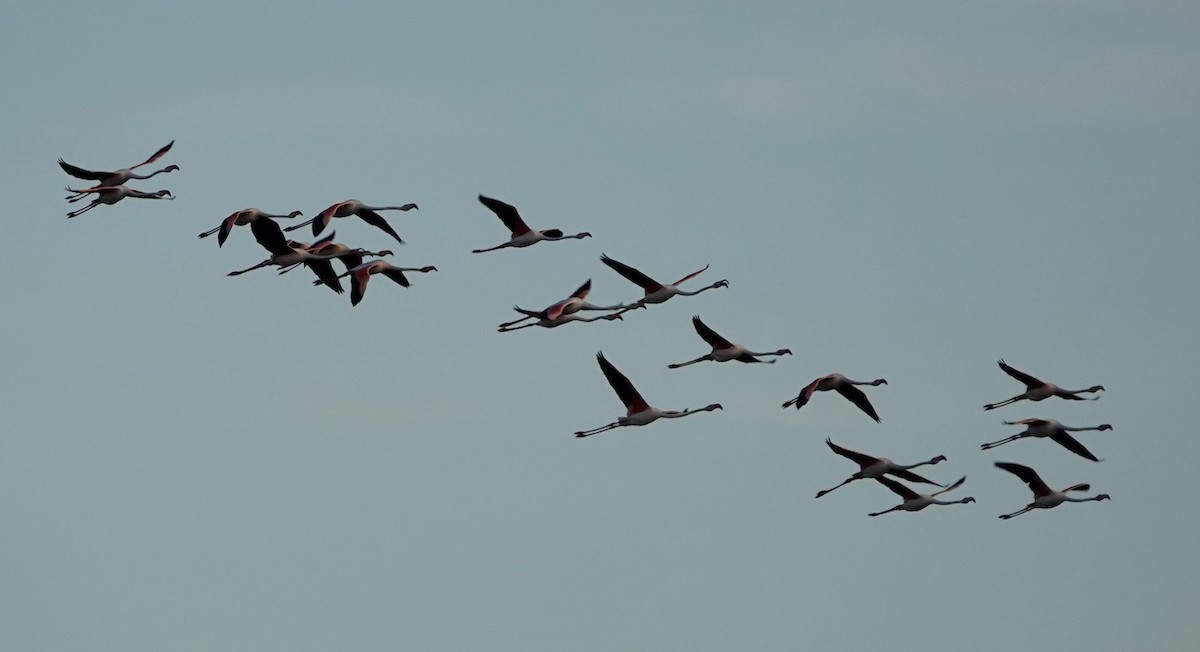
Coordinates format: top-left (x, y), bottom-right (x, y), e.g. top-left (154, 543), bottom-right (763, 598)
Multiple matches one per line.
top-left (59, 140), bottom-right (1112, 520)
